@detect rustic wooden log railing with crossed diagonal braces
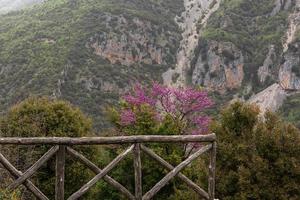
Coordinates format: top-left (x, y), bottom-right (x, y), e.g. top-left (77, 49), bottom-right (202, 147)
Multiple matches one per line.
top-left (0, 134), bottom-right (216, 200)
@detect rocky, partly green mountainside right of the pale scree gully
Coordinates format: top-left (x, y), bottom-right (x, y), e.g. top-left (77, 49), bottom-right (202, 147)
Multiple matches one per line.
top-left (166, 0), bottom-right (300, 119)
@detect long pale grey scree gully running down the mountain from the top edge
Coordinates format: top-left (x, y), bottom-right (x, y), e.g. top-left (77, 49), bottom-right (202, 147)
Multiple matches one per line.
top-left (163, 0), bottom-right (221, 85)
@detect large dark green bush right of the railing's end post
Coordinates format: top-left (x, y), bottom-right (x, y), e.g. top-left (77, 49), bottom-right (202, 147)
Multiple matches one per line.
top-left (212, 102), bottom-right (300, 200)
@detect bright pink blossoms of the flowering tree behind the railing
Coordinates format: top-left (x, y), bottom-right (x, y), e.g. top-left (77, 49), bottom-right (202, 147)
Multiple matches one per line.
top-left (121, 82), bottom-right (213, 132)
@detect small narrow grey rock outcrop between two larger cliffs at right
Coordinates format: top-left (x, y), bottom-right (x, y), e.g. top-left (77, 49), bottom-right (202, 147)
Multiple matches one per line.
top-left (257, 45), bottom-right (277, 83)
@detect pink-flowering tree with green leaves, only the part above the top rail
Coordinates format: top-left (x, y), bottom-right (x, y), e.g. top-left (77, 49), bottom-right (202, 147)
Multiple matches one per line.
top-left (113, 83), bottom-right (213, 135)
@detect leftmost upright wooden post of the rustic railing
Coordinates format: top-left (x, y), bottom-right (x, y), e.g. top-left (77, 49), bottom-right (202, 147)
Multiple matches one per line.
top-left (55, 145), bottom-right (66, 200)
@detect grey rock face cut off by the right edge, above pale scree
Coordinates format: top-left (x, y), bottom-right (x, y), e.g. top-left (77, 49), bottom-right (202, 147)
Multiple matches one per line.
top-left (279, 43), bottom-right (300, 90)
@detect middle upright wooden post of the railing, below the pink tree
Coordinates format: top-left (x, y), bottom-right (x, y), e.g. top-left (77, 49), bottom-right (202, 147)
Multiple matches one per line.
top-left (133, 143), bottom-right (143, 200)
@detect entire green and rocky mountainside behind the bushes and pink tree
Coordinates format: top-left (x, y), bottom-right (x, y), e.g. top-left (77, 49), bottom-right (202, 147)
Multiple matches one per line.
top-left (0, 0), bottom-right (300, 128)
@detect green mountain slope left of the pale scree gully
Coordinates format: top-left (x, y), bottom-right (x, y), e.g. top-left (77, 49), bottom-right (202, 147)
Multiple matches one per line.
top-left (0, 0), bottom-right (181, 130)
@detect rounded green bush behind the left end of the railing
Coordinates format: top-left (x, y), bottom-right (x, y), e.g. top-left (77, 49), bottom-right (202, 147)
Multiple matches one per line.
top-left (0, 97), bottom-right (97, 197)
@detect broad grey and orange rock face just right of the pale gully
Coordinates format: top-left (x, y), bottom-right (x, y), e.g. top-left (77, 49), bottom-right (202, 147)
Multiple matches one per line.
top-left (192, 41), bottom-right (244, 93)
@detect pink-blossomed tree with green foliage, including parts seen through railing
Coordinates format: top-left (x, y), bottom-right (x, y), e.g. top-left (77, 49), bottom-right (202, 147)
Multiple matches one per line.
top-left (105, 83), bottom-right (213, 199)
